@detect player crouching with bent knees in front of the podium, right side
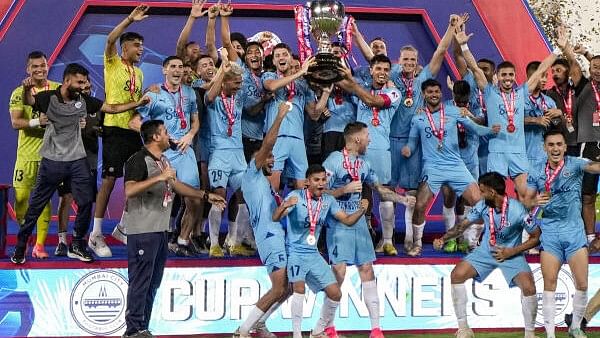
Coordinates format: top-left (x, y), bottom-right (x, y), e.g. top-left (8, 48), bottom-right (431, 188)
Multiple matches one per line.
top-left (433, 172), bottom-right (540, 338)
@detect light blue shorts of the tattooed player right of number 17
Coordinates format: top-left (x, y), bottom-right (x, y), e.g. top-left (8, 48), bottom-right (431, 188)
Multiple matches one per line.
top-left (326, 222), bottom-right (376, 266)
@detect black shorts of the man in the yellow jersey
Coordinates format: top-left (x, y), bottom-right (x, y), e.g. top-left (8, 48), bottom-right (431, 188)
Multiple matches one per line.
top-left (102, 127), bottom-right (143, 178)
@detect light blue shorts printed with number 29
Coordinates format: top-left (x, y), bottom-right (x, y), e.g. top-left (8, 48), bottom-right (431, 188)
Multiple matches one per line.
top-left (208, 149), bottom-right (248, 191)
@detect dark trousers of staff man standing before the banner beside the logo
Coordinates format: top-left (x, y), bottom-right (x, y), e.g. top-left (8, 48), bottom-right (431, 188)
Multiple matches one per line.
top-left (125, 231), bottom-right (169, 335)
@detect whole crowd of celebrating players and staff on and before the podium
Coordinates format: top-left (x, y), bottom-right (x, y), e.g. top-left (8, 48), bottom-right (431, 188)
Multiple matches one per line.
top-left (10, 0), bottom-right (600, 338)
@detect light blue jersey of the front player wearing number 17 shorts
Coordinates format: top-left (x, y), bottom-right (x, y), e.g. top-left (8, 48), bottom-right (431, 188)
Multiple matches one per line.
top-left (286, 189), bottom-right (342, 254)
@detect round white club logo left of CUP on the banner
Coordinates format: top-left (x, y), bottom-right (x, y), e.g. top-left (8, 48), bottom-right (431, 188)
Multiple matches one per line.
top-left (70, 270), bottom-right (127, 335)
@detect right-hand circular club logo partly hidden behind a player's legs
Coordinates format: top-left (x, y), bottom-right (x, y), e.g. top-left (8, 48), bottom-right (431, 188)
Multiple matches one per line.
top-left (533, 268), bottom-right (575, 326)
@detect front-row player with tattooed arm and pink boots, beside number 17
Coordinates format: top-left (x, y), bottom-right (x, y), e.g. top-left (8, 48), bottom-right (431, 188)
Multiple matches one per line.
top-left (323, 122), bottom-right (414, 338)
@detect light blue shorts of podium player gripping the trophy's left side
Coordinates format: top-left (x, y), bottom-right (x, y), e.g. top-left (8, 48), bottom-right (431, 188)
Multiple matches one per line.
top-left (273, 136), bottom-right (308, 180)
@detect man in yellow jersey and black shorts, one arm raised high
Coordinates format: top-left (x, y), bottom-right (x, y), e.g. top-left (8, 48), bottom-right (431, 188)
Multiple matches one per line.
top-left (88, 4), bottom-right (149, 257)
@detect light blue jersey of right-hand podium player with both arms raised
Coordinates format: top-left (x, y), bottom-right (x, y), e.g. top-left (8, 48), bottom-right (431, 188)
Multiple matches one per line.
top-left (483, 84), bottom-right (529, 154)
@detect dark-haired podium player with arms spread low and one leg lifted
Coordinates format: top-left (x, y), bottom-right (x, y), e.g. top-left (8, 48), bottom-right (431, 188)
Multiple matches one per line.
top-left (402, 79), bottom-right (500, 256)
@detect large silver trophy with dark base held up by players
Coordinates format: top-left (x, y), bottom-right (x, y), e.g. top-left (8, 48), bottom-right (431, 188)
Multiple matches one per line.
top-left (308, 0), bottom-right (345, 84)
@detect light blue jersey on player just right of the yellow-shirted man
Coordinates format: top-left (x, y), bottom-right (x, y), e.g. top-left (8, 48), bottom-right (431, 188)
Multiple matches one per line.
top-left (137, 85), bottom-right (198, 140)
